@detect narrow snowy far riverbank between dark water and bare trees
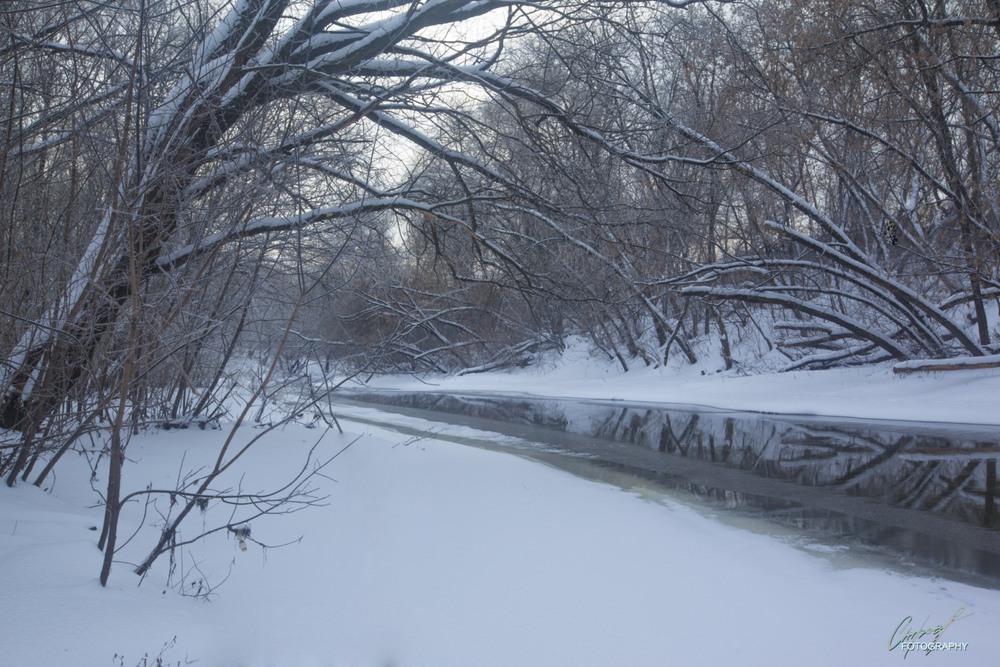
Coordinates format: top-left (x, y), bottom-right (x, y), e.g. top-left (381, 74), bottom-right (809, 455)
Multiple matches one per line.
top-left (354, 345), bottom-right (1000, 425)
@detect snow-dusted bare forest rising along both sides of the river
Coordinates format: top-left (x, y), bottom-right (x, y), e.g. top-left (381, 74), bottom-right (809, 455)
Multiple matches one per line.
top-left (0, 0), bottom-right (1000, 582)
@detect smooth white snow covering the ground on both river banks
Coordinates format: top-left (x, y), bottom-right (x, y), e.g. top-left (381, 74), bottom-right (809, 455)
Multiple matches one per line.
top-left (0, 348), bottom-right (1000, 667)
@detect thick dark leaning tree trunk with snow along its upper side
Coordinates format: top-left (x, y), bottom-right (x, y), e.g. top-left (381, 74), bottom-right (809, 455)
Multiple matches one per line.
top-left (0, 0), bottom-right (288, 474)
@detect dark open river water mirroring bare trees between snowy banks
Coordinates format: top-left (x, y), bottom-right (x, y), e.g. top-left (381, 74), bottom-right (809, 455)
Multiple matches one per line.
top-left (340, 392), bottom-right (1000, 581)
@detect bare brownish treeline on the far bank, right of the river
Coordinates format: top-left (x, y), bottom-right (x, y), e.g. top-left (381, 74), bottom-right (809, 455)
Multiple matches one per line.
top-left (368, 2), bottom-right (1000, 376)
